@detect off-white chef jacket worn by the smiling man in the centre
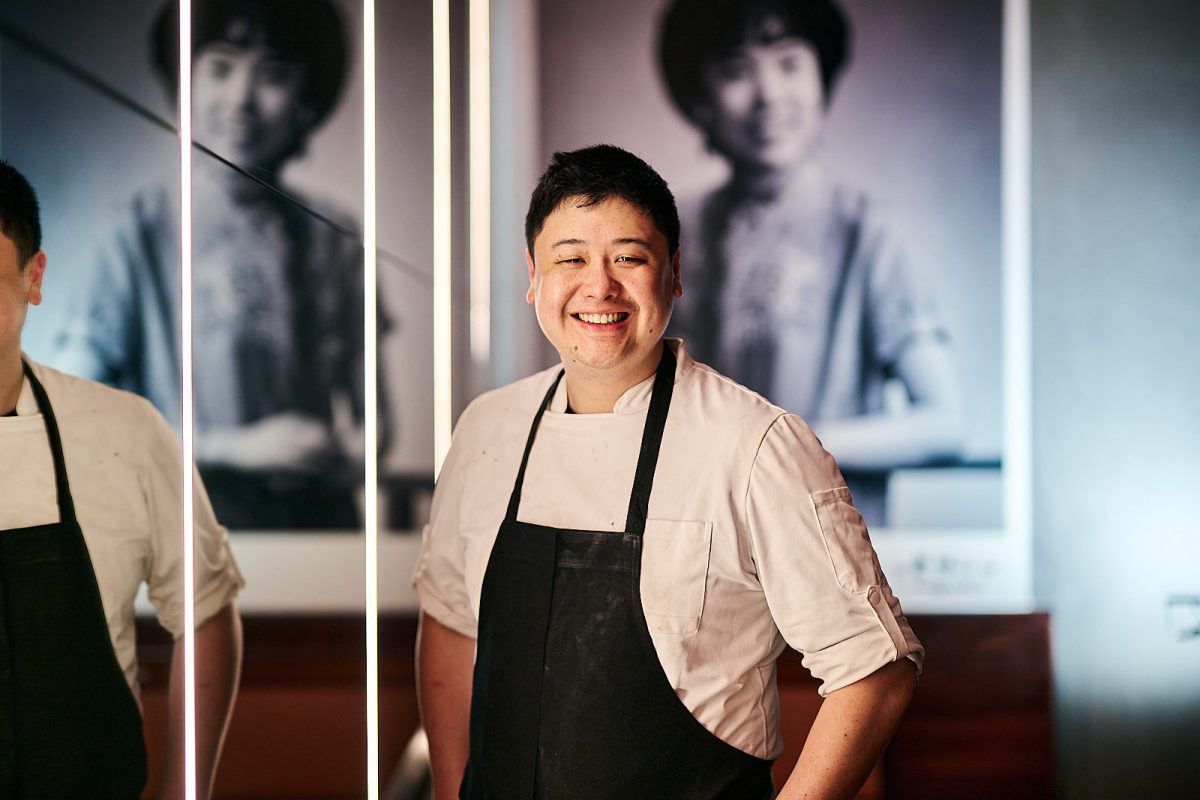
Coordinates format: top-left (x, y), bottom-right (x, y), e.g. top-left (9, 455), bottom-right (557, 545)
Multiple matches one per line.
top-left (413, 339), bottom-right (924, 758)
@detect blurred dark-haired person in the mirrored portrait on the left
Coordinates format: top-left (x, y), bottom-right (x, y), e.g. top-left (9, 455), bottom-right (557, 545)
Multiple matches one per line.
top-left (54, 0), bottom-right (364, 530)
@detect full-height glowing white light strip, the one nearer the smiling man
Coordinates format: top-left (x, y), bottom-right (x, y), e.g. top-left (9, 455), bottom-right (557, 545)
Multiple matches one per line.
top-left (362, 0), bottom-right (379, 800)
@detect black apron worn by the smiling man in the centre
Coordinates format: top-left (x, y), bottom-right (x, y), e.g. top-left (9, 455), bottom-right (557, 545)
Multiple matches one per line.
top-left (460, 347), bottom-right (773, 800)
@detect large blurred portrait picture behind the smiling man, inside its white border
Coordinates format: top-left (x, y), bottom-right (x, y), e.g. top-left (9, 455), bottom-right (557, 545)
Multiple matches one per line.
top-left (541, 0), bottom-right (1003, 537)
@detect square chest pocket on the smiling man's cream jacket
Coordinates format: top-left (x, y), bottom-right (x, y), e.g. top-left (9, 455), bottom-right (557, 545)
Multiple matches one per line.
top-left (641, 519), bottom-right (713, 636)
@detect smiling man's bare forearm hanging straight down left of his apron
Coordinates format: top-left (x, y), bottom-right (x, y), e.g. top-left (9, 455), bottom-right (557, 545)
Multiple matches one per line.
top-left (416, 613), bottom-right (475, 800)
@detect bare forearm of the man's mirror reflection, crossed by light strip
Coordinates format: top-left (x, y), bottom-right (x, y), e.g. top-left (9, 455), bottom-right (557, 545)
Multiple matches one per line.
top-left (158, 602), bottom-right (241, 800)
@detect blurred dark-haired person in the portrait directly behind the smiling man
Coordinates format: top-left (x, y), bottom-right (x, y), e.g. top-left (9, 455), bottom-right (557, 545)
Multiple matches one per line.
top-left (658, 0), bottom-right (962, 524)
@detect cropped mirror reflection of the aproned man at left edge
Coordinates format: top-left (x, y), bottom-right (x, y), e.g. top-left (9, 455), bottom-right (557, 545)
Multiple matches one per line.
top-left (0, 161), bottom-right (242, 800)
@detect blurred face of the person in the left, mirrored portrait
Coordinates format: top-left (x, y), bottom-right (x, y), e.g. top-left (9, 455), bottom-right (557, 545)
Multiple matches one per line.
top-left (192, 42), bottom-right (314, 172)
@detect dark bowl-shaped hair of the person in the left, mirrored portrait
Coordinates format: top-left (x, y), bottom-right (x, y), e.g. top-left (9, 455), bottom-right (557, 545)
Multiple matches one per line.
top-left (150, 0), bottom-right (347, 127)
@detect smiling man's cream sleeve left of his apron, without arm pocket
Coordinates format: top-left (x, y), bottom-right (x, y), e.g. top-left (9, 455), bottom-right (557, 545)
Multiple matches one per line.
top-left (413, 409), bottom-right (478, 638)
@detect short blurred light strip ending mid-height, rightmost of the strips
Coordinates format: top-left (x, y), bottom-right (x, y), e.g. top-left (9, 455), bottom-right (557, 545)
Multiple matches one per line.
top-left (467, 0), bottom-right (492, 366)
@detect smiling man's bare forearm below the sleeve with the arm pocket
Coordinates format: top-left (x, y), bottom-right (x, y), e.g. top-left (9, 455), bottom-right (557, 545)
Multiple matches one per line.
top-left (779, 658), bottom-right (917, 800)
